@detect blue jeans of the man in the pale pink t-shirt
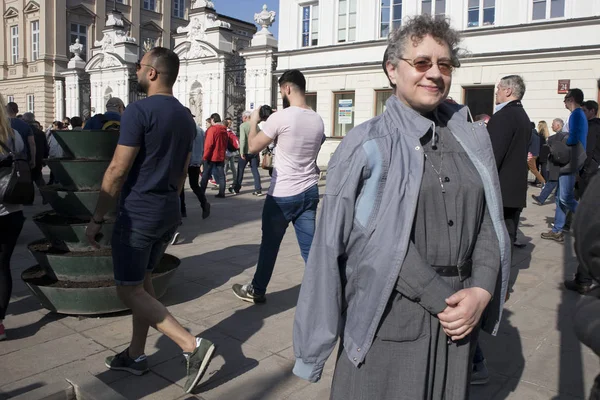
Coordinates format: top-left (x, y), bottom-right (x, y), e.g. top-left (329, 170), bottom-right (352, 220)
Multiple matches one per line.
top-left (252, 185), bottom-right (319, 295)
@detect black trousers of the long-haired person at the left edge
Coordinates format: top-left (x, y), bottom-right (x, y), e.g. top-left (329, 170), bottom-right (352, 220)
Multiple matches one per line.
top-left (0, 211), bottom-right (25, 321)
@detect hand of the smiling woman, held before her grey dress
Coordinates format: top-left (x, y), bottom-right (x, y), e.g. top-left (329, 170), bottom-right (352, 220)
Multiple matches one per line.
top-left (438, 287), bottom-right (492, 341)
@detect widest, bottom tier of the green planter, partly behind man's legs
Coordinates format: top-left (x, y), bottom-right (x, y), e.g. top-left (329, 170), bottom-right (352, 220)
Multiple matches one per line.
top-left (21, 254), bottom-right (180, 315)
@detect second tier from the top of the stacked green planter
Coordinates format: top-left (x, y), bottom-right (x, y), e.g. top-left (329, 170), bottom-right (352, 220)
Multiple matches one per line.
top-left (46, 158), bottom-right (110, 190)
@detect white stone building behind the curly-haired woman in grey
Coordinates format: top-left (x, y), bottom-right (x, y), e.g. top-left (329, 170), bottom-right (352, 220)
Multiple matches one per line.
top-left (275, 0), bottom-right (600, 147)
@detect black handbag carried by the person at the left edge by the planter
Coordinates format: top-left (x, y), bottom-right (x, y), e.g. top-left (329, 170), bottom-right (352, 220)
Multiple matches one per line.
top-left (0, 141), bottom-right (35, 204)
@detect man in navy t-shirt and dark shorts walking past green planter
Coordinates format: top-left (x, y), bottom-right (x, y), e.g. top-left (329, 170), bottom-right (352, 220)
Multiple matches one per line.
top-left (86, 47), bottom-right (215, 393)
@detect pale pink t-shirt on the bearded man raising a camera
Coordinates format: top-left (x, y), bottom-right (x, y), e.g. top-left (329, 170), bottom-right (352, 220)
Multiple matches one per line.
top-left (262, 107), bottom-right (325, 197)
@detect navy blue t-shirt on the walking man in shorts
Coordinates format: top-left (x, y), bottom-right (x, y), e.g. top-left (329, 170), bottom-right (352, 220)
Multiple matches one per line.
top-left (119, 95), bottom-right (196, 230)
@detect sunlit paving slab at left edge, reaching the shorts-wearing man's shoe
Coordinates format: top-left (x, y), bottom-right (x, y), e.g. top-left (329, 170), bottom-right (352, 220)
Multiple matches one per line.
top-left (0, 333), bottom-right (105, 386)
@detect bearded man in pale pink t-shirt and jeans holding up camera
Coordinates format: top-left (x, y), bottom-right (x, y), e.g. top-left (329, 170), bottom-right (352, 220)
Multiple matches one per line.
top-left (233, 70), bottom-right (325, 303)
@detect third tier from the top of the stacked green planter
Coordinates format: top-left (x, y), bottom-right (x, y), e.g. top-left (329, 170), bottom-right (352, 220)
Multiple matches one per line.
top-left (40, 186), bottom-right (116, 220)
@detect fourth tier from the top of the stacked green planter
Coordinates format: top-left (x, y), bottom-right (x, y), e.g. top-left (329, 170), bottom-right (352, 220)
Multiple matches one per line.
top-left (33, 211), bottom-right (114, 251)
